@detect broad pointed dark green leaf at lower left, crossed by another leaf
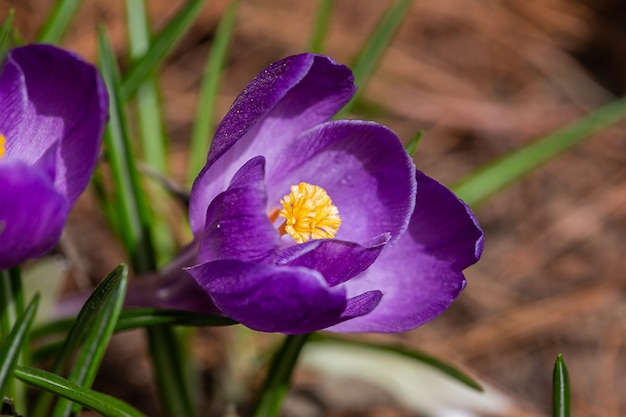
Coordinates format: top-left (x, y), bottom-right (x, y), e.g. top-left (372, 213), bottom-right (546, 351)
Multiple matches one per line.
top-left (53, 266), bottom-right (128, 417)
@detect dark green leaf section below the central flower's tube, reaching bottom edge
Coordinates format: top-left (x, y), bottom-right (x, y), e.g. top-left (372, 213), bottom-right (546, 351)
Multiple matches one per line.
top-left (147, 326), bottom-right (198, 417)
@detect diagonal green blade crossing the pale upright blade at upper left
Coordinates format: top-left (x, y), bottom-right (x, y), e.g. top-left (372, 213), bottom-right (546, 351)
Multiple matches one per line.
top-left (121, 0), bottom-right (207, 99)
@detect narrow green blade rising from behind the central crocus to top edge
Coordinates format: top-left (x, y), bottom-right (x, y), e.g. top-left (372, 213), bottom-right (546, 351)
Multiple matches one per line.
top-left (187, 0), bottom-right (240, 185)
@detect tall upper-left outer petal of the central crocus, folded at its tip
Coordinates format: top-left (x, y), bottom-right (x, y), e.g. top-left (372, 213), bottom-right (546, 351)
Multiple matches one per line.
top-left (189, 54), bottom-right (356, 234)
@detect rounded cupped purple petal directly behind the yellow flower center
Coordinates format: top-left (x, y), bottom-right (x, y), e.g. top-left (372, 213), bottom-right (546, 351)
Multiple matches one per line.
top-left (266, 120), bottom-right (415, 245)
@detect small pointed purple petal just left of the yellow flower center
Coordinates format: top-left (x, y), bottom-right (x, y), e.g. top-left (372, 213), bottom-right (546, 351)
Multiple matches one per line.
top-left (198, 156), bottom-right (279, 262)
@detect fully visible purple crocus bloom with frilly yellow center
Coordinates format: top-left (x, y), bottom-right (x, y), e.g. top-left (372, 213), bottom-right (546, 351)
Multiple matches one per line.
top-left (130, 54), bottom-right (483, 334)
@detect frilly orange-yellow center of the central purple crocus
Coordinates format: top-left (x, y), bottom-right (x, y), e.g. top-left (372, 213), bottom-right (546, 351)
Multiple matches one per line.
top-left (278, 182), bottom-right (341, 243)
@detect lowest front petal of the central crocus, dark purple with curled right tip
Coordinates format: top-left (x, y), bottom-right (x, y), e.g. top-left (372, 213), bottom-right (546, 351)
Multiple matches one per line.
top-left (187, 260), bottom-right (380, 334)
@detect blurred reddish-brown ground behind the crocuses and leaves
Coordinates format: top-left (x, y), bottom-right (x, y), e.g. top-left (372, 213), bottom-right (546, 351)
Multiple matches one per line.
top-left (0, 0), bottom-right (626, 417)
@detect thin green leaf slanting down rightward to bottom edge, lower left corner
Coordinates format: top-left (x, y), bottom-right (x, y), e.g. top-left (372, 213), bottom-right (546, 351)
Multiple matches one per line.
top-left (14, 366), bottom-right (145, 417)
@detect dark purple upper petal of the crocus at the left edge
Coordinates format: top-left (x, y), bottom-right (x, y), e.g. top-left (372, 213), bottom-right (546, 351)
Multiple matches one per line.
top-left (0, 45), bottom-right (108, 203)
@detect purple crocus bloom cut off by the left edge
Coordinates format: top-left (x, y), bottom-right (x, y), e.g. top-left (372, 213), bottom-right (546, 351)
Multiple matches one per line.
top-left (0, 45), bottom-right (108, 270)
